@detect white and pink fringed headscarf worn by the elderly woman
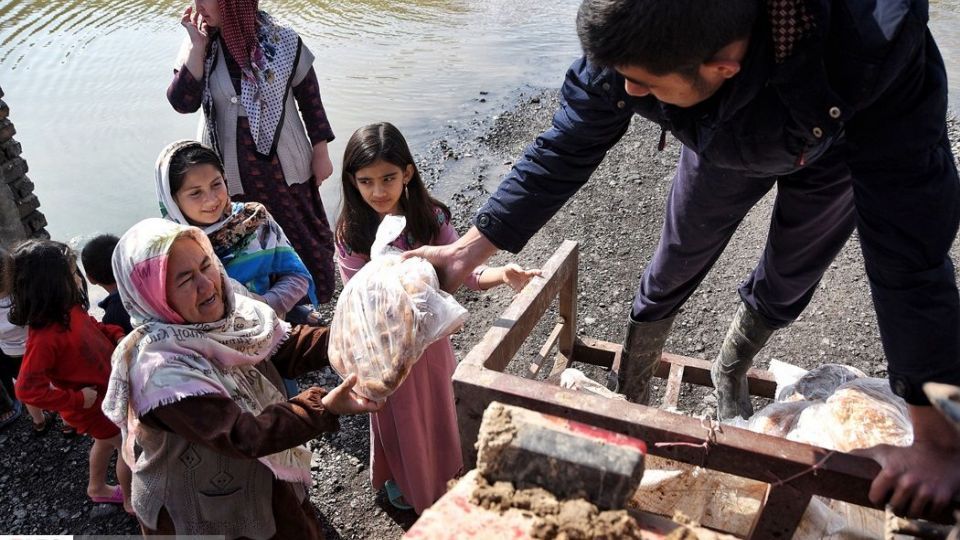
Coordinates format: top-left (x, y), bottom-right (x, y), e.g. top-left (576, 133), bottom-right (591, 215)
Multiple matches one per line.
top-left (103, 218), bottom-right (310, 484)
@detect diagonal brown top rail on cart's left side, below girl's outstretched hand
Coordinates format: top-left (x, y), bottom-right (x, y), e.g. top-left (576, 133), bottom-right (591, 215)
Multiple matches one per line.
top-left (461, 240), bottom-right (577, 371)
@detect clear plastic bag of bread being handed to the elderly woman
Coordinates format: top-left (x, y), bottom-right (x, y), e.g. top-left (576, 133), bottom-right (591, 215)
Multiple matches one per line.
top-left (328, 216), bottom-right (467, 401)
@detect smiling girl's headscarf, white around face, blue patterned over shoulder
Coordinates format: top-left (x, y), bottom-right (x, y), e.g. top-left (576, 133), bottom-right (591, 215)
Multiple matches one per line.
top-left (156, 140), bottom-right (318, 304)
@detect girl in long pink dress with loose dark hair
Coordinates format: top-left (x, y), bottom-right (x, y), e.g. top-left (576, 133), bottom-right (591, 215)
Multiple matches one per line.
top-left (336, 123), bottom-right (540, 513)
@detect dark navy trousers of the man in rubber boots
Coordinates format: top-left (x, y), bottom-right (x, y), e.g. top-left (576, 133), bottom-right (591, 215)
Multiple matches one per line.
top-left (632, 148), bottom-right (854, 328)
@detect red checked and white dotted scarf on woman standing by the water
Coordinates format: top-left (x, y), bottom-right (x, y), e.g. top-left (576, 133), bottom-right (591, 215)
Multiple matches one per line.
top-left (202, 0), bottom-right (300, 156)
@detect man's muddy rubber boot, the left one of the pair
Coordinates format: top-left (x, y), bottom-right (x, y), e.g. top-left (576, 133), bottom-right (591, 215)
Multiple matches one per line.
top-left (611, 316), bottom-right (676, 405)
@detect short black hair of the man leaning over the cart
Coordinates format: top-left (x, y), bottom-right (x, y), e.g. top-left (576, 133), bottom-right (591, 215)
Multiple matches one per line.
top-left (577, 0), bottom-right (760, 77)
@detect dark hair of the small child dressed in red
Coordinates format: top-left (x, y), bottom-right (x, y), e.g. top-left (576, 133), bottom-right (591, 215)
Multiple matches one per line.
top-left (10, 240), bottom-right (90, 328)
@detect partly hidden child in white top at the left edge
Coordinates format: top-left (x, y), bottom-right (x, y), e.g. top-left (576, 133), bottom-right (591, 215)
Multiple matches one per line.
top-left (0, 246), bottom-right (53, 435)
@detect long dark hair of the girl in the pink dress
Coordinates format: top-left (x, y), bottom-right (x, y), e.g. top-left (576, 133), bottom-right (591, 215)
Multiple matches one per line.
top-left (337, 122), bottom-right (450, 255)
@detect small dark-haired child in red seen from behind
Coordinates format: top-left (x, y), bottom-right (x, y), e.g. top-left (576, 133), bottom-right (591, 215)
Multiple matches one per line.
top-left (10, 240), bottom-right (131, 511)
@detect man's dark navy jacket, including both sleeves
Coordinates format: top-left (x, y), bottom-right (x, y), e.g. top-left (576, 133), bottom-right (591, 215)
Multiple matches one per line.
top-left (474, 0), bottom-right (960, 403)
